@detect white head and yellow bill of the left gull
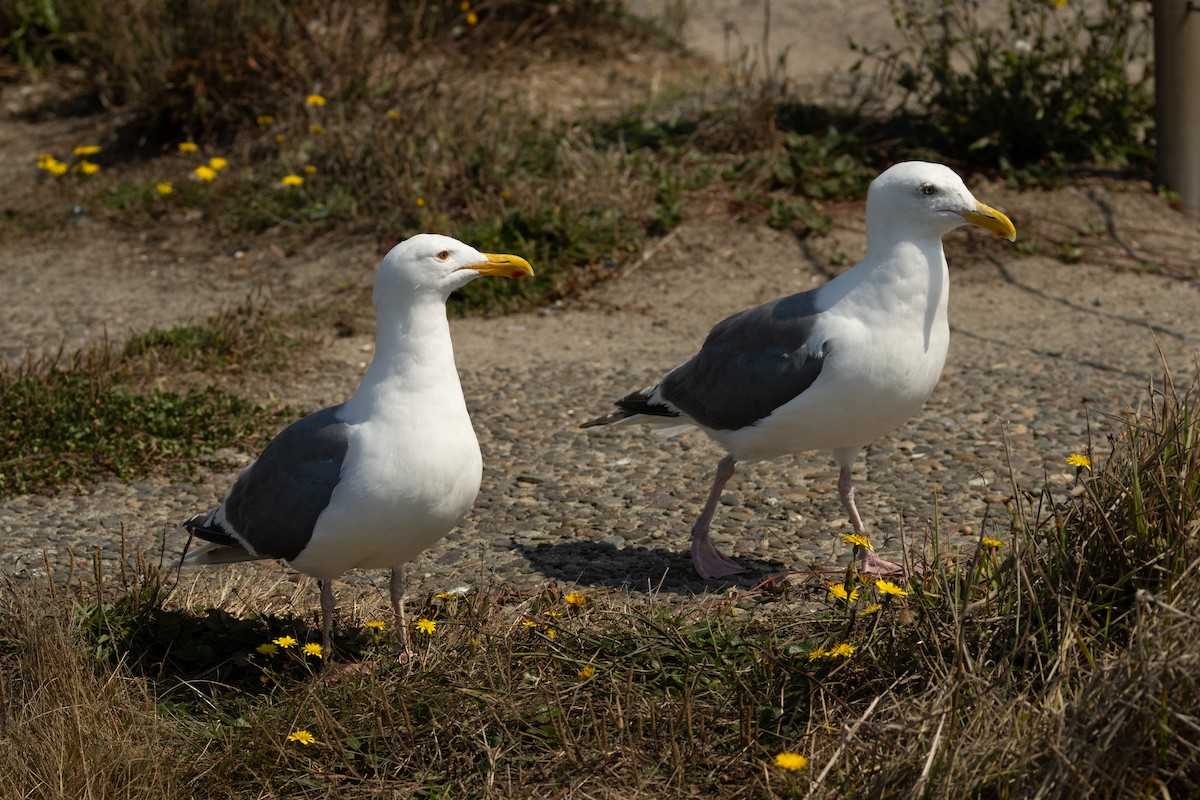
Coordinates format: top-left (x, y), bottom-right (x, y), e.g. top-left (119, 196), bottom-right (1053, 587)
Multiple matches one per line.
top-left (374, 234), bottom-right (533, 306)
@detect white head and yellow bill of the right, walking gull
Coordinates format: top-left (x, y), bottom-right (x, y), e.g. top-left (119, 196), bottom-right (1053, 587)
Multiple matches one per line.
top-left (866, 161), bottom-right (1016, 247)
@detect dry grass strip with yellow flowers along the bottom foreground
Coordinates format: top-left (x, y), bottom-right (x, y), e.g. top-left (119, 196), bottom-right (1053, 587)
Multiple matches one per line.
top-left (0, 371), bottom-right (1200, 800)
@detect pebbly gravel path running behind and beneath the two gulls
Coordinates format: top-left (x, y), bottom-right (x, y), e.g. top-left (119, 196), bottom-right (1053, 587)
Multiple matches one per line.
top-left (0, 187), bottom-right (1200, 612)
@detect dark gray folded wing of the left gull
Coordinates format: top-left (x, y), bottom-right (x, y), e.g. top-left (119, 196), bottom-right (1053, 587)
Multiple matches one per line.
top-left (186, 405), bottom-right (349, 560)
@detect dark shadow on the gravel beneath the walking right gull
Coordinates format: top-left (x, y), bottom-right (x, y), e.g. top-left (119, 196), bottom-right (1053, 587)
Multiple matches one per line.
top-left (514, 540), bottom-right (788, 594)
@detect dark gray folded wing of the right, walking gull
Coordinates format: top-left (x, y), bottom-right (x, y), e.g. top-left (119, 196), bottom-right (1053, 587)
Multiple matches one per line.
top-left (659, 291), bottom-right (828, 431)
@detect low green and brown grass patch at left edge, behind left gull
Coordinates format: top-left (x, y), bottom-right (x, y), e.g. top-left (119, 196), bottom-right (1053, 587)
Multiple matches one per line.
top-left (0, 302), bottom-right (308, 497)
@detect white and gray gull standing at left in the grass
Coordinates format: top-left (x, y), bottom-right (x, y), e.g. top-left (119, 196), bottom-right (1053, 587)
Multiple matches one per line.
top-left (184, 234), bottom-right (533, 652)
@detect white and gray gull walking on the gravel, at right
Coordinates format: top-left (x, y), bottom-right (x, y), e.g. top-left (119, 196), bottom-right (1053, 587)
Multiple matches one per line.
top-left (583, 162), bottom-right (1016, 578)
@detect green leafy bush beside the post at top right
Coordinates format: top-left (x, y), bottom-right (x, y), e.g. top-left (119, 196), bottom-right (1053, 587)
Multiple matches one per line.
top-left (874, 0), bottom-right (1153, 176)
